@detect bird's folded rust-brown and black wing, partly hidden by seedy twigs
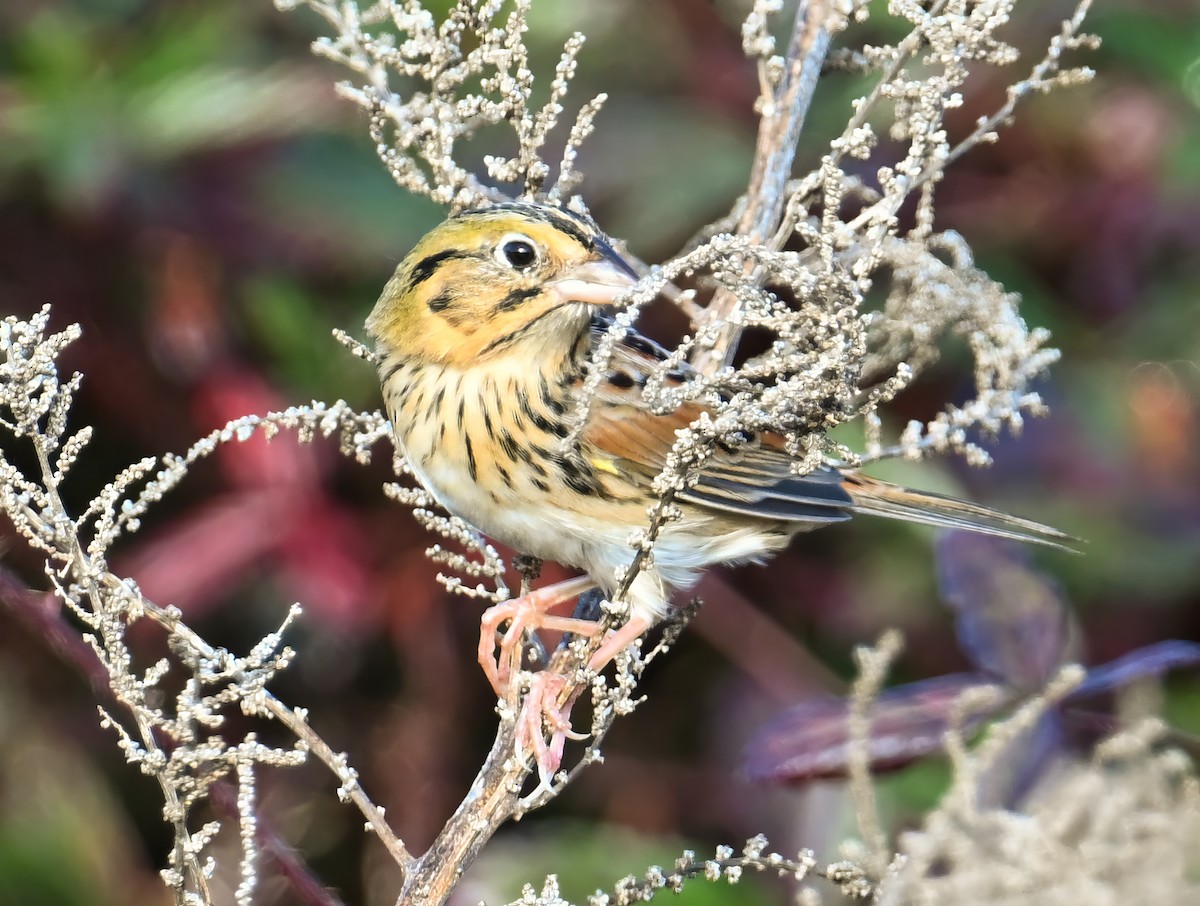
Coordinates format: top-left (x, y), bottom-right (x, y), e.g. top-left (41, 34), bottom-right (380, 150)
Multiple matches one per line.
top-left (583, 322), bottom-right (852, 522)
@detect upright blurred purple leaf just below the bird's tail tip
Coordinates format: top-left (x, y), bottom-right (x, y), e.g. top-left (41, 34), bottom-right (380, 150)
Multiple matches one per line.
top-left (937, 532), bottom-right (1067, 691)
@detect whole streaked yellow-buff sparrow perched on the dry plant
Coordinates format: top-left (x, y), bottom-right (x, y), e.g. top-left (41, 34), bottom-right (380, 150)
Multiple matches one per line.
top-left (366, 202), bottom-right (1070, 776)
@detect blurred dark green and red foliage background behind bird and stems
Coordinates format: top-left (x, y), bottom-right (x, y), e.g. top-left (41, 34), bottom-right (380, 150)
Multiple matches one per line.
top-left (0, 0), bottom-right (1200, 905)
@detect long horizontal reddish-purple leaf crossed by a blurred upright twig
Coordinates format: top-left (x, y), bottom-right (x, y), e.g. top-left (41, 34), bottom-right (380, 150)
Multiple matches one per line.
top-left (742, 673), bottom-right (1003, 784)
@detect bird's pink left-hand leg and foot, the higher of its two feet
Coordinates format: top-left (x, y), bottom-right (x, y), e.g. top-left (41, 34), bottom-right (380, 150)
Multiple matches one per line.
top-left (479, 576), bottom-right (596, 698)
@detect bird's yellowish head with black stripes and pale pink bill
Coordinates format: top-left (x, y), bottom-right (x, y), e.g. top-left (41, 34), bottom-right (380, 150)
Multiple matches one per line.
top-left (366, 203), bottom-right (637, 366)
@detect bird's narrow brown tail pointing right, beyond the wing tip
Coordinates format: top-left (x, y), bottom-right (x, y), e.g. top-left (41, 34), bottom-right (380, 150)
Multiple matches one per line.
top-left (841, 472), bottom-right (1076, 550)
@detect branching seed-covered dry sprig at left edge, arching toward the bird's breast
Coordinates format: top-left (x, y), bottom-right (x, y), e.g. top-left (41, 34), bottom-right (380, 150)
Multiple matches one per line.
top-left (0, 310), bottom-right (412, 904)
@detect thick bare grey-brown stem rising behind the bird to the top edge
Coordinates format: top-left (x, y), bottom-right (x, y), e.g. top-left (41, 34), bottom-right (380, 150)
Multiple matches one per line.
top-left (694, 0), bottom-right (830, 374)
